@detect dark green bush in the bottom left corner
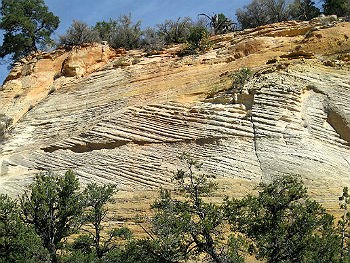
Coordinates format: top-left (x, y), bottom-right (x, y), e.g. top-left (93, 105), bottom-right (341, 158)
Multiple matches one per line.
top-left (0, 195), bottom-right (49, 263)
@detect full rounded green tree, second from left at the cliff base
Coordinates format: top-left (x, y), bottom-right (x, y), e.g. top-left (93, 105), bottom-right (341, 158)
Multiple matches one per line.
top-left (20, 171), bottom-right (84, 262)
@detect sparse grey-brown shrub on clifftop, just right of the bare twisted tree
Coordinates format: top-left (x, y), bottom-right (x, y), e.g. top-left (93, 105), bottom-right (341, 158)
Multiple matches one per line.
top-left (236, 0), bottom-right (289, 29)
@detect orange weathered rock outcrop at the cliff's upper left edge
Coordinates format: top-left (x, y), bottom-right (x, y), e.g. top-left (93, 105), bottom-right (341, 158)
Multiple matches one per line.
top-left (1, 44), bottom-right (119, 128)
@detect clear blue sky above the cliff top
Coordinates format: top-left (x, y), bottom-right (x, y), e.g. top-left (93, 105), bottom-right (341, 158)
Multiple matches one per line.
top-left (0, 0), bottom-right (246, 83)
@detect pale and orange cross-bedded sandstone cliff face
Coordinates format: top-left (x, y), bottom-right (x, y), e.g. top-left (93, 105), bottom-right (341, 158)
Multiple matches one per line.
top-left (0, 21), bottom-right (350, 205)
